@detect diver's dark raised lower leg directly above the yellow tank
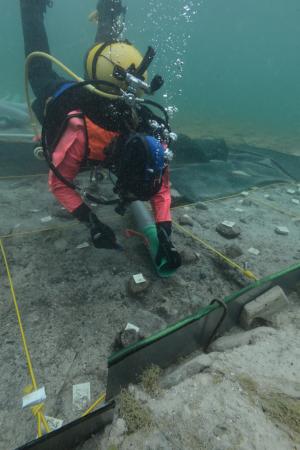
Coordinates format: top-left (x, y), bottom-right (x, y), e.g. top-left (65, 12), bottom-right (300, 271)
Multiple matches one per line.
top-left (96, 0), bottom-right (127, 42)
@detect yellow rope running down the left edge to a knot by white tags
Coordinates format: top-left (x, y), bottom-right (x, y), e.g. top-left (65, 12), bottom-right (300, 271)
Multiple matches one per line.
top-left (0, 240), bottom-right (50, 437)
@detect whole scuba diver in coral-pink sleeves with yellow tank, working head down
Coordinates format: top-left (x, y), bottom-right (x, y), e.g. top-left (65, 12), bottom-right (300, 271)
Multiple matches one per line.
top-left (20, 0), bottom-right (181, 269)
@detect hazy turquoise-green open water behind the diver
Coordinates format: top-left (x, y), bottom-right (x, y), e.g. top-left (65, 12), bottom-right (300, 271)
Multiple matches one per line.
top-left (0, 0), bottom-right (300, 152)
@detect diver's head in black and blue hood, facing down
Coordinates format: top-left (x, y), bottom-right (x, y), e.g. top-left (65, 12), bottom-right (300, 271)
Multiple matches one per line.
top-left (113, 133), bottom-right (167, 203)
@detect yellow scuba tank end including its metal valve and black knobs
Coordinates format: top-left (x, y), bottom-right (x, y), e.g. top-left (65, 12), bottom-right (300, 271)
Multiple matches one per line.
top-left (85, 41), bottom-right (163, 97)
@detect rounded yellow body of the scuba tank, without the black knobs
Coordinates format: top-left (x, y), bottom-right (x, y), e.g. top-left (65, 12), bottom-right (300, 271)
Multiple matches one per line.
top-left (85, 42), bottom-right (149, 92)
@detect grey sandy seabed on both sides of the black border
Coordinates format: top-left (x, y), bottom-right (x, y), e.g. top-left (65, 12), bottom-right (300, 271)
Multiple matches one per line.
top-left (0, 170), bottom-right (300, 450)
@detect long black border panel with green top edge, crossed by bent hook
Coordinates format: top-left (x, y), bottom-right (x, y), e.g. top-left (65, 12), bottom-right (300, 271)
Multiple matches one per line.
top-left (107, 263), bottom-right (300, 399)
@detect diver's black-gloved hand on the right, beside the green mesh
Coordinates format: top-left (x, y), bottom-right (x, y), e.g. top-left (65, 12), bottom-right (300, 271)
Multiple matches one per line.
top-left (155, 222), bottom-right (181, 270)
